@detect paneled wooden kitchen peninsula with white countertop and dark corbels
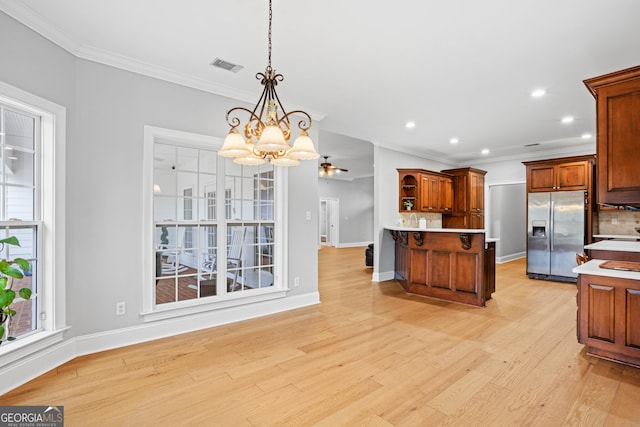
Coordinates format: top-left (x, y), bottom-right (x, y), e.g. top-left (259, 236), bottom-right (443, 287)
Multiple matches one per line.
top-left (386, 226), bottom-right (497, 306)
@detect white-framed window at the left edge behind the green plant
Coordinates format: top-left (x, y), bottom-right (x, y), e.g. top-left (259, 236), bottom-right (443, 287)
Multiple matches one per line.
top-left (0, 82), bottom-right (66, 354)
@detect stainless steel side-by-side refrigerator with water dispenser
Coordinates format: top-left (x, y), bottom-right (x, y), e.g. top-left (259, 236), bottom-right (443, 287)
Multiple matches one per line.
top-left (527, 190), bottom-right (585, 281)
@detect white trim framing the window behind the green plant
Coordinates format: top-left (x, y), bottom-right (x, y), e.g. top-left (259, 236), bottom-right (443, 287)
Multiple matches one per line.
top-left (0, 82), bottom-right (68, 358)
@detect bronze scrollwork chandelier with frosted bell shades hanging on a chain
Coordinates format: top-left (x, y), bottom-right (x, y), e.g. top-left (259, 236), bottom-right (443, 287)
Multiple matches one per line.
top-left (218, 0), bottom-right (320, 166)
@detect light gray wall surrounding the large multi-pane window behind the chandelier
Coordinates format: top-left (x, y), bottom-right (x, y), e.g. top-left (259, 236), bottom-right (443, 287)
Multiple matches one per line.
top-left (0, 12), bottom-right (318, 337)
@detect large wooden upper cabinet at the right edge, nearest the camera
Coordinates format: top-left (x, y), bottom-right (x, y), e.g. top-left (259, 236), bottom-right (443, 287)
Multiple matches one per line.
top-left (584, 66), bottom-right (640, 205)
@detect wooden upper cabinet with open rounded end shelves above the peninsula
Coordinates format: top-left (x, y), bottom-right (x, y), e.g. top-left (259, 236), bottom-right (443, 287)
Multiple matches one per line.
top-left (398, 169), bottom-right (453, 213)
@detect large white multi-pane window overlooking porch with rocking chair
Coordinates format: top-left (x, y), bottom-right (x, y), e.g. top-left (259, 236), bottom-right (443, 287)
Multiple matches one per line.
top-left (143, 127), bottom-right (283, 320)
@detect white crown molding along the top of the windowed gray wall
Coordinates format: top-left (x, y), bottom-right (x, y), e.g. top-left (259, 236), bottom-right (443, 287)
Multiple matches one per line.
top-left (0, 0), bottom-right (326, 121)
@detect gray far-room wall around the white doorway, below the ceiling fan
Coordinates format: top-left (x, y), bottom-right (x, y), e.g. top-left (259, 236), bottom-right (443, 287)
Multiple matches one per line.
top-left (318, 176), bottom-right (373, 247)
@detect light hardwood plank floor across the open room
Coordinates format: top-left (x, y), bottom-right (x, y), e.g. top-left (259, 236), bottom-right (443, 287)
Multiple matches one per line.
top-left (0, 247), bottom-right (640, 427)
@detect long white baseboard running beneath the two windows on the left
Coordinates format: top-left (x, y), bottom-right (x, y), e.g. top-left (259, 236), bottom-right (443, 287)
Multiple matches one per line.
top-left (0, 292), bottom-right (320, 396)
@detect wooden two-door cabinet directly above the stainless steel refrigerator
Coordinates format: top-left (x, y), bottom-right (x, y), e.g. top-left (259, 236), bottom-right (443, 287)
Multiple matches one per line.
top-left (524, 155), bottom-right (595, 193)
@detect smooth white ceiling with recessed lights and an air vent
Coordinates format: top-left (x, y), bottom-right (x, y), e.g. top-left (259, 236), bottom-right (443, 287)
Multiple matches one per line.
top-left (0, 0), bottom-right (640, 176)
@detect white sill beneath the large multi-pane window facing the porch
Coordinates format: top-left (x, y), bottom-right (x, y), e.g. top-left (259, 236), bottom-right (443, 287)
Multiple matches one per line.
top-left (140, 288), bottom-right (288, 322)
